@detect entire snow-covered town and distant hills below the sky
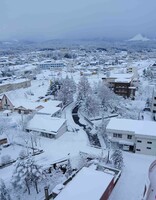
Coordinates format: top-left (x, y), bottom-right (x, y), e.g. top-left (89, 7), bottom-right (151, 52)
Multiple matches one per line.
top-left (0, 34), bottom-right (156, 200)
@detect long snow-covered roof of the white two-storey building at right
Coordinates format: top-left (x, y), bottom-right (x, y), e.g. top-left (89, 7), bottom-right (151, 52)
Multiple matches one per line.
top-left (107, 118), bottom-right (156, 137)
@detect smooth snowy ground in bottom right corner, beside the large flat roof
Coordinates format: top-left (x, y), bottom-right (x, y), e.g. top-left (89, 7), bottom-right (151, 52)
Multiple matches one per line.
top-left (109, 152), bottom-right (155, 200)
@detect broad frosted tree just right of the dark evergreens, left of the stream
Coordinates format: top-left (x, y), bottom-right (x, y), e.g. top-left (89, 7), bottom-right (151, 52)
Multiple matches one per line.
top-left (57, 76), bottom-right (76, 105)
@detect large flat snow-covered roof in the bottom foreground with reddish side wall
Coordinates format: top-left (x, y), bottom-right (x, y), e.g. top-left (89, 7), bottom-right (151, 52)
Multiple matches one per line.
top-left (55, 167), bottom-right (113, 200)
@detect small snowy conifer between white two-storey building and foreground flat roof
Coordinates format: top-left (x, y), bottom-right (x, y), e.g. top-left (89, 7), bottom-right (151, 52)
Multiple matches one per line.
top-left (111, 149), bottom-right (123, 169)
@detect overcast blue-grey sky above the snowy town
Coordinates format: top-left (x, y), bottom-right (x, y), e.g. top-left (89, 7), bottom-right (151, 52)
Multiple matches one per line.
top-left (0, 0), bottom-right (156, 40)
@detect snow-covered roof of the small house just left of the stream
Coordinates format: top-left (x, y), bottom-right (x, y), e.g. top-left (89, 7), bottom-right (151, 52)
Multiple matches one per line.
top-left (27, 115), bottom-right (66, 134)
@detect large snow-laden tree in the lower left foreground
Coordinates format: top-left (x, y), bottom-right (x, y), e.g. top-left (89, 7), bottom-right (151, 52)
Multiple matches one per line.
top-left (12, 156), bottom-right (46, 194)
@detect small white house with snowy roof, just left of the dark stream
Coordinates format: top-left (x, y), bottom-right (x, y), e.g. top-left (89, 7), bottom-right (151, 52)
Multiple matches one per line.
top-left (26, 115), bottom-right (67, 138)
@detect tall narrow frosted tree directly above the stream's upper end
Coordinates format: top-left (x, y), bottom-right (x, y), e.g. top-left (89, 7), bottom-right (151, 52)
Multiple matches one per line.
top-left (77, 76), bottom-right (91, 102)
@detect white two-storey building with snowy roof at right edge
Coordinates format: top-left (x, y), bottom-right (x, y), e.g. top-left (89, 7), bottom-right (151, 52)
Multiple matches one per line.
top-left (106, 118), bottom-right (156, 155)
